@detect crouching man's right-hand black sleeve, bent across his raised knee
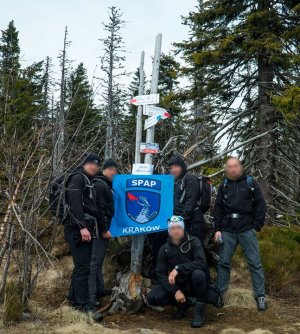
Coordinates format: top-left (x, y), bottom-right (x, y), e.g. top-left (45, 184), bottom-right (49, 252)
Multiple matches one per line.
top-left (178, 238), bottom-right (207, 276)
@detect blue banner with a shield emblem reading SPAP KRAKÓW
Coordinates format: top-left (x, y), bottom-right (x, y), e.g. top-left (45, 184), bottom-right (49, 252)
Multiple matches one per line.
top-left (110, 175), bottom-right (174, 237)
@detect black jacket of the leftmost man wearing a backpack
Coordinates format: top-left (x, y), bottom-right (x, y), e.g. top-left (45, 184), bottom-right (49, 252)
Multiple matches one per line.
top-left (66, 168), bottom-right (98, 229)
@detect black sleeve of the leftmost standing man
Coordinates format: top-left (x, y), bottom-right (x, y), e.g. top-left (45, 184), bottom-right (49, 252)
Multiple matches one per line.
top-left (66, 174), bottom-right (87, 229)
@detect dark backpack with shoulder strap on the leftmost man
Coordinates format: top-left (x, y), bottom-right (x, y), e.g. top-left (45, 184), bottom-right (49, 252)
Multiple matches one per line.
top-left (49, 171), bottom-right (91, 223)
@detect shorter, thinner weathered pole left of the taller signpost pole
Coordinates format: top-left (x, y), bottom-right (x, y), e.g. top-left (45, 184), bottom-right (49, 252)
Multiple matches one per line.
top-left (134, 51), bottom-right (145, 163)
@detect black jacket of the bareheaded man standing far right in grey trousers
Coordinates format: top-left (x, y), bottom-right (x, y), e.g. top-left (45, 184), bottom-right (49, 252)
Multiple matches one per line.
top-left (214, 175), bottom-right (266, 232)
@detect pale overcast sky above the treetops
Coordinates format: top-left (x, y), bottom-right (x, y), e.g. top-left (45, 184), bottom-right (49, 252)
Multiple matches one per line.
top-left (0, 0), bottom-right (197, 83)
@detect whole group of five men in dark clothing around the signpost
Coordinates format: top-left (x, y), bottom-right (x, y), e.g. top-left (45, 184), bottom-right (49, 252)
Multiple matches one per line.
top-left (65, 154), bottom-right (267, 328)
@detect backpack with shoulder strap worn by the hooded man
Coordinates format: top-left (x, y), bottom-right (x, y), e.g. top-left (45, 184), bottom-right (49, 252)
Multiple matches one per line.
top-left (180, 174), bottom-right (213, 213)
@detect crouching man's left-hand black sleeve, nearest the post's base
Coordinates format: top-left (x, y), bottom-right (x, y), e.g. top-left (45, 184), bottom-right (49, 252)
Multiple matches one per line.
top-left (156, 246), bottom-right (179, 294)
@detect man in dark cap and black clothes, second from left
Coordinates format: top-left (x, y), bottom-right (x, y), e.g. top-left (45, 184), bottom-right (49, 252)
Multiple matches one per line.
top-left (89, 159), bottom-right (118, 307)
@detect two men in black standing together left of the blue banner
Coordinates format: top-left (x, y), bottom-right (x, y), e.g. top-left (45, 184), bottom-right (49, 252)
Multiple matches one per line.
top-left (64, 154), bottom-right (118, 321)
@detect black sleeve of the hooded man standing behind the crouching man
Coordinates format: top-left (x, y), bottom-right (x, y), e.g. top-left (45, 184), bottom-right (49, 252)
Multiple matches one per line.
top-left (183, 174), bottom-right (200, 223)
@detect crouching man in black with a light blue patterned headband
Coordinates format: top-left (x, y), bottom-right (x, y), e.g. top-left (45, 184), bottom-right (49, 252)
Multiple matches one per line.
top-left (147, 216), bottom-right (208, 328)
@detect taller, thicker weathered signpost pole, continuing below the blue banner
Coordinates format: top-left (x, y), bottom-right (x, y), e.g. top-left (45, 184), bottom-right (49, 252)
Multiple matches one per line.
top-left (130, 34), bottom-right (162, 274)
